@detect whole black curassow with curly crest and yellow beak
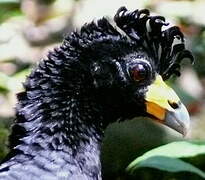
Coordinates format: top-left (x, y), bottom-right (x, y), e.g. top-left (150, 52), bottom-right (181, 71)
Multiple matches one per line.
top-left (0, 7), bottom-right (193, 180)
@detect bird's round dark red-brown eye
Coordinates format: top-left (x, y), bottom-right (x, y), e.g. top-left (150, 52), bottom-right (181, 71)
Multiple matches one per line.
top-left (129, 64), bottom-right (148, 82)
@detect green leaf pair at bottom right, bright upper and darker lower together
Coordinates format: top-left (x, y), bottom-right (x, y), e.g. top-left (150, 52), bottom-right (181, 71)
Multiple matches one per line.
top-left (127, 141), bottom-right (205, 177)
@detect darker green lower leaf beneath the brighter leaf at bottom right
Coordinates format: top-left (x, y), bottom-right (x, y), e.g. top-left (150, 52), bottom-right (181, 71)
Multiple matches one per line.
top-left (130, 156), bottom-right (205, 178)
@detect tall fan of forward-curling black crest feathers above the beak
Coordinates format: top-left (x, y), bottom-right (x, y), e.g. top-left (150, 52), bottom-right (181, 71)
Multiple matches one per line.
top-left (114, 7), bottom-right (194, 79)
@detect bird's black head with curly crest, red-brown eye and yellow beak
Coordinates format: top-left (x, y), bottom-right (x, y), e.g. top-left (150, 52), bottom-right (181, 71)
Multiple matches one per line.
top-left (62, 7), bottom-right (193, 135)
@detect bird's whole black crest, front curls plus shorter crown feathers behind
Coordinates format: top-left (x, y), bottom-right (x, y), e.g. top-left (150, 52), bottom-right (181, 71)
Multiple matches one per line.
top-left (64, 7), bottom-right (194, 80)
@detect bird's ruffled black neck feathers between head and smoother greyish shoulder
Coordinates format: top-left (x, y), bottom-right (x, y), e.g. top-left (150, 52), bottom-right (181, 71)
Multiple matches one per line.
top-left (10, 47), bottom-right (103, 155)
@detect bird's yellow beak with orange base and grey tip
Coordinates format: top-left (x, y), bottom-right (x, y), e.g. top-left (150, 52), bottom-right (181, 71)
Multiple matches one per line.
top-left (145, 75), bottom-right (190, 135)
